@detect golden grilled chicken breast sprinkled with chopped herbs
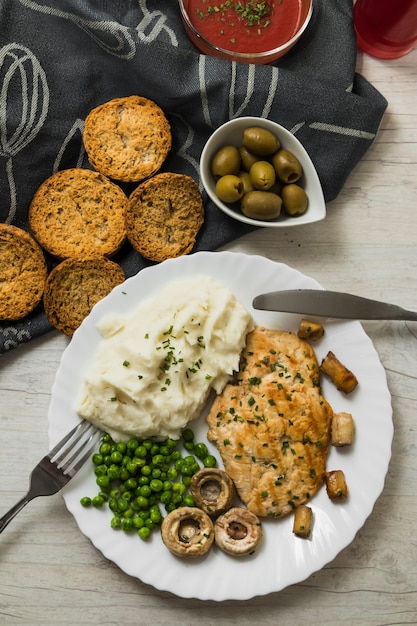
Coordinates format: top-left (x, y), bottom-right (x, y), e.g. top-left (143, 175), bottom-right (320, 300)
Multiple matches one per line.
top-left (206, 326), bottom-right (332, 517)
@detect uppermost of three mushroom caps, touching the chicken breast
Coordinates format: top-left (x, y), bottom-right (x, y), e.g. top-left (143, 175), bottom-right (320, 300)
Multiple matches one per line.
top-left (190, 467), bottom-right (236, 515)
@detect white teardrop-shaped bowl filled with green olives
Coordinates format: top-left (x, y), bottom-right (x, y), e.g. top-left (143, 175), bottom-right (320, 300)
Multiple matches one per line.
top-left (200, 117), bottom-right (326, 228)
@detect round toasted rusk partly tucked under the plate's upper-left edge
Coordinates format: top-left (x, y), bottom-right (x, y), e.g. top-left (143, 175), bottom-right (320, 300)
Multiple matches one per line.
top-left (43, 256), bottom-right (125, 337)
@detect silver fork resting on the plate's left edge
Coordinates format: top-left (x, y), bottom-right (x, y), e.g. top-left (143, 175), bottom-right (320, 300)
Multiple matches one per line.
top-left (0, 420), bottom-right (100, 533)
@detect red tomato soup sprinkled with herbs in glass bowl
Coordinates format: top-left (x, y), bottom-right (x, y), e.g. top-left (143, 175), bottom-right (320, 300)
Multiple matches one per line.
top-left (188, 0), bottom-right (305, 54)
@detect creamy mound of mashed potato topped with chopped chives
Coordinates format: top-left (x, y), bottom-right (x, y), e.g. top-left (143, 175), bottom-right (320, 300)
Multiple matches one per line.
top-left (77, 277), bottom-right (253, 441)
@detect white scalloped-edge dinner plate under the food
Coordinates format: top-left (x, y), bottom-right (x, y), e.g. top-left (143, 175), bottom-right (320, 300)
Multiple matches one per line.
top-left (49, 252), bottom-right (393, 601)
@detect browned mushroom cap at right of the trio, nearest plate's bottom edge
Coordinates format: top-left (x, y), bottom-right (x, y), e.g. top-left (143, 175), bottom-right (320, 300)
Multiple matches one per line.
top-left (214, 506), bottom-right (263, 556)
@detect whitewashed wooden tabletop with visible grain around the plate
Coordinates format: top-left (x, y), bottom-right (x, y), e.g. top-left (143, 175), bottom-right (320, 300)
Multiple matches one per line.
top-left (0, 48), bottom-right (417, 626)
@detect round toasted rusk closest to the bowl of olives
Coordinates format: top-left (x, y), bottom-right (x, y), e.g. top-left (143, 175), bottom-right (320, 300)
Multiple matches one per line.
top-left (126, 172), bottom-right (204, 261)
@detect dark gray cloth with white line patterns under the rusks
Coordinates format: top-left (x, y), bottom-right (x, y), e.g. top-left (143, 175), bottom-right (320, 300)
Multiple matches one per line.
top-left (0, 0), bottom-right (387, 353)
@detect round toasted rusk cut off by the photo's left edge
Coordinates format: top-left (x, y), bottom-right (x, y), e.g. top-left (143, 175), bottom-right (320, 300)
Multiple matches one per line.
top-left (0, 224), bottom-right (47, 321)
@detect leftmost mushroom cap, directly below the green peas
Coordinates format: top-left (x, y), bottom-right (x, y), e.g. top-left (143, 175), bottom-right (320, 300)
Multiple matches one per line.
top-left (161, 506), bottom-right (214, 556)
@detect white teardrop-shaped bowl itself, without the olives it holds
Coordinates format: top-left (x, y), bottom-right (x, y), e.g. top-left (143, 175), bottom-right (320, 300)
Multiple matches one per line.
top-left (200, 116), bottom-right (327, 228)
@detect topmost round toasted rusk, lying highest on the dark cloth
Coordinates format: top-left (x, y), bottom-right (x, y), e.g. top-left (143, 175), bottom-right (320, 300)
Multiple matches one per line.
top-left (84, 96), bottom-right (172, 182)
